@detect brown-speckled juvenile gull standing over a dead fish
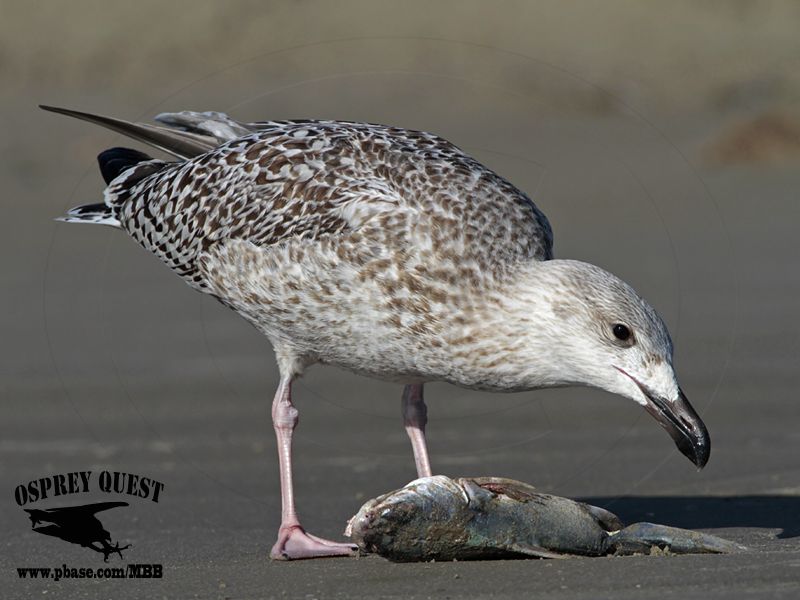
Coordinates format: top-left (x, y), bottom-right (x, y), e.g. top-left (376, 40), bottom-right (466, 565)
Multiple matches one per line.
top-left (43, 107), bottom-right (710, 559)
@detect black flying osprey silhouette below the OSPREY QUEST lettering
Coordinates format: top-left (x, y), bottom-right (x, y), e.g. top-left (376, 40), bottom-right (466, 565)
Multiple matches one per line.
top-left (23, 502), bottom-right (131, 562)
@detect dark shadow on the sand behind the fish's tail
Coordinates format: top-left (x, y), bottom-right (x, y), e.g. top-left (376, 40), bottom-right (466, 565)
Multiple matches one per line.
top-left (580, 496), bottom-right (800, 539)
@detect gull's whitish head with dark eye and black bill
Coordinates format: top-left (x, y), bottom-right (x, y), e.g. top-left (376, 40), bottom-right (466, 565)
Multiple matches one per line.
top-left (537, 260), bottom-right (711, 468)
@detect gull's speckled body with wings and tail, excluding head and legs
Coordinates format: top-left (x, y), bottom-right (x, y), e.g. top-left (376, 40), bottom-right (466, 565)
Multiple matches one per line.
top-left (48, 110), bottom-right (552, 380)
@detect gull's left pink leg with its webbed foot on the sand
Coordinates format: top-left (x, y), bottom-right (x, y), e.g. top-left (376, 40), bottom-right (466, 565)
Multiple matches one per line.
top-left (270, 377), bottom-right (357, 560)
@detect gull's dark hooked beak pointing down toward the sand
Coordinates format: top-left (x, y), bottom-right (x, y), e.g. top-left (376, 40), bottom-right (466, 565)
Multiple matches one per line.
top-left (634, 380), bottom-right (711, 469)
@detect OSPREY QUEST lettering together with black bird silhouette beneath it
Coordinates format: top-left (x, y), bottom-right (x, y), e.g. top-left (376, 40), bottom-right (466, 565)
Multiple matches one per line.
top-left (14, 471), bottom-right (164, 562)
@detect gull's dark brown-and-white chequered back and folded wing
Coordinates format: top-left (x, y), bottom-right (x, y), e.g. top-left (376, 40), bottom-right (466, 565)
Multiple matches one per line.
top-left (98, 113), bottom-right (552, 289)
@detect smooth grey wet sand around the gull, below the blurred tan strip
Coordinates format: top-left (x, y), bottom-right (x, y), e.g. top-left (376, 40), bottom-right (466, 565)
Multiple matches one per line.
top-left (0, 3), bottom-right (800, 599)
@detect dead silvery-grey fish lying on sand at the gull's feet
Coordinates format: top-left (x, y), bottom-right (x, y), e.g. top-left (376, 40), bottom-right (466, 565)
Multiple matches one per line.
top-left (345, 475), bottom-right (744, 562)
